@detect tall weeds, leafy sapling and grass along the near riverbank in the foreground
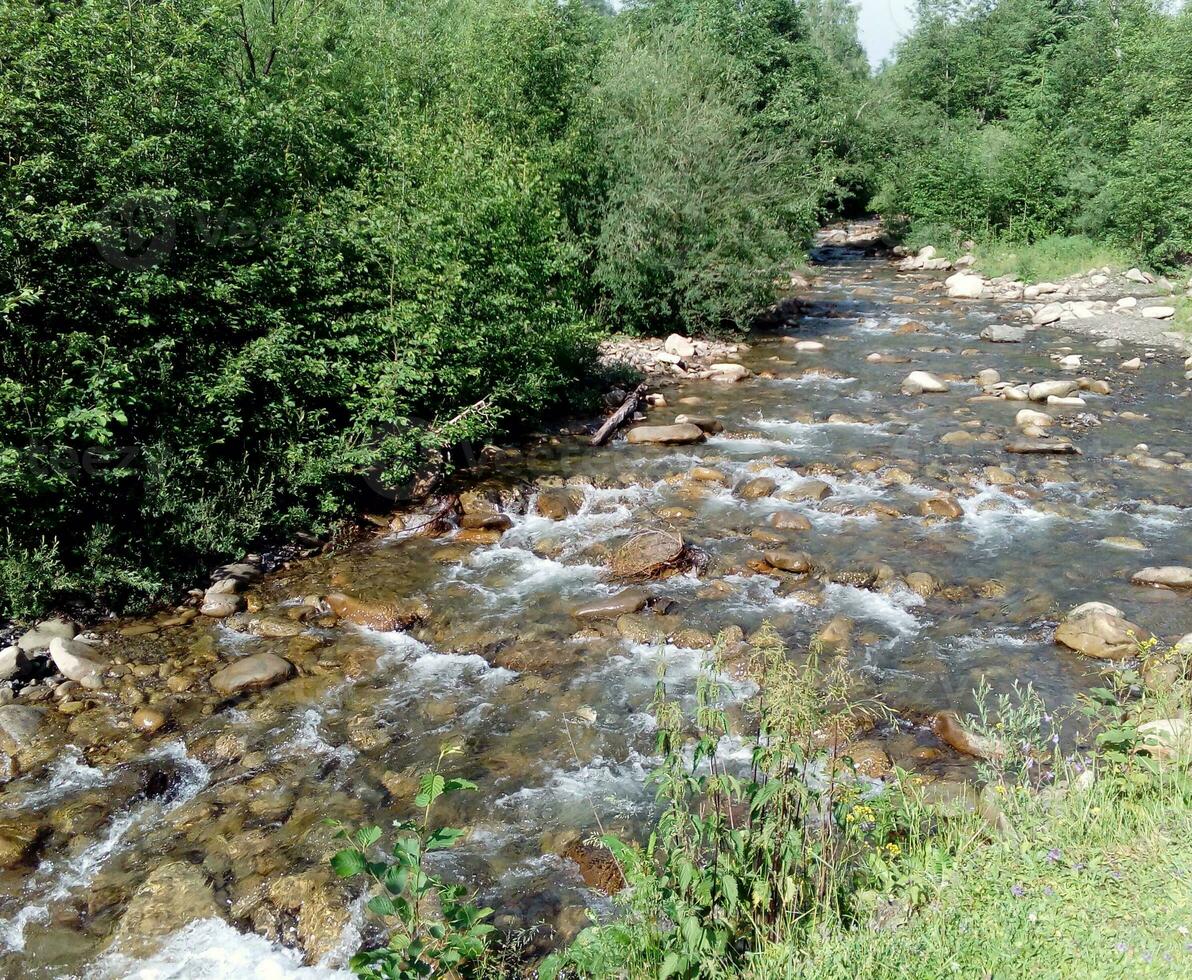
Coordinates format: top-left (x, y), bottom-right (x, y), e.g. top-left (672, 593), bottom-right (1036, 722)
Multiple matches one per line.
top-left (334, 627), bottom-right (1192, 980)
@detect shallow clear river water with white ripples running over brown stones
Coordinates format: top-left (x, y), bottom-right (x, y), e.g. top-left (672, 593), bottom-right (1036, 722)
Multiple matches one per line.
top-left (0, 233), bottom-right (1192, 978)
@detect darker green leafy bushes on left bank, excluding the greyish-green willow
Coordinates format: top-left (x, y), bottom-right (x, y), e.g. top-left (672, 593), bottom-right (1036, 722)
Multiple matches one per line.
top-left (0, 0), bottom-right (594, 615)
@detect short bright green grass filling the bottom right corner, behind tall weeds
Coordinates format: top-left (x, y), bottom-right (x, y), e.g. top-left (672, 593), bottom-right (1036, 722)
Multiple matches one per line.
top-left (750, 784), bottom-right (1192, 980)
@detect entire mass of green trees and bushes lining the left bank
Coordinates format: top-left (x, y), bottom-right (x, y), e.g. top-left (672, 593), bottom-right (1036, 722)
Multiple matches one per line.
top-left (0, 0), bottom-right (868, 618)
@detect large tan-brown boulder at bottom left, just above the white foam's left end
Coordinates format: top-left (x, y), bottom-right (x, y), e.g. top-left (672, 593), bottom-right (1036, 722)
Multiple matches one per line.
top-left (112, 861), bottom-right (219, 956)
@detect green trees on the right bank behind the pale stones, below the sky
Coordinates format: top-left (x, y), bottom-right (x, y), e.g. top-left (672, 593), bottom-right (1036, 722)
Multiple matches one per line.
top-left (875, 0), bottom-right (1192, 269)
